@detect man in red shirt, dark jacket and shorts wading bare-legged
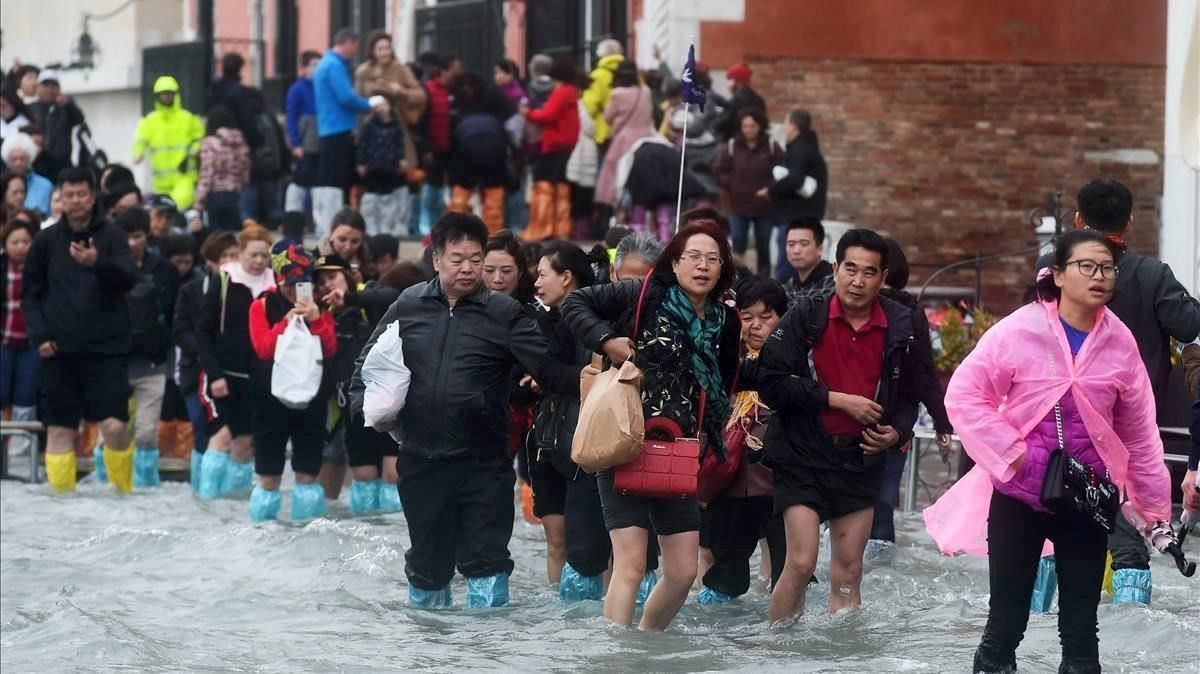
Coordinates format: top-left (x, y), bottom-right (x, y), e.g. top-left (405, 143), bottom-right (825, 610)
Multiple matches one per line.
top-left (758, 229), bottom-right (919, 622)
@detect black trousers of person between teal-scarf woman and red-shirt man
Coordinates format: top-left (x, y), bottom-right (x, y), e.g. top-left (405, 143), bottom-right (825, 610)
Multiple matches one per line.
top-left (703, 497), bottom-right (787, 597)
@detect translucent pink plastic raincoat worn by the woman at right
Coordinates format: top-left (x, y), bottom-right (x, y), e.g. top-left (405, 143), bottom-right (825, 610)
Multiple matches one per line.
top-left (924, 302), bottom-right (1171, 556)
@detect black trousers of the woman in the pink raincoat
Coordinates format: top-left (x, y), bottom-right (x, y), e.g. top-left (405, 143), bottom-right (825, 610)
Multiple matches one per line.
top-left (978, 492), bottom-right (1108, 670)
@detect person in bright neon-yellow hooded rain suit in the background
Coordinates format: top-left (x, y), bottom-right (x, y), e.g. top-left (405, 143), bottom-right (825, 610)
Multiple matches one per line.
top-left (133, 76), bottom-right (204, 210)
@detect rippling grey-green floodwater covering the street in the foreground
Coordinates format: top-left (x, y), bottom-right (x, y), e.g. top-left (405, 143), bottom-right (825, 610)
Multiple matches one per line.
top-left (0, 472), bottom-right (1200, 673)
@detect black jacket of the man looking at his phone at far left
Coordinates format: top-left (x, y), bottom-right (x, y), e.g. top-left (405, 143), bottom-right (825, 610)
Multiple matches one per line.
top-left (20, 213), bottom-right (138, 355)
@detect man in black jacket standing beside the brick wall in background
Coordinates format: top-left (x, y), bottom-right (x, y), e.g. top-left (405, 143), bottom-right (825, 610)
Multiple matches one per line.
top-left (758, 110), bottom-right (829, 282)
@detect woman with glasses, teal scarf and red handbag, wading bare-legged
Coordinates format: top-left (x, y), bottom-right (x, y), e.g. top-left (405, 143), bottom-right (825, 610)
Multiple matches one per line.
top-left (562, 222), bottom-right (740, 631)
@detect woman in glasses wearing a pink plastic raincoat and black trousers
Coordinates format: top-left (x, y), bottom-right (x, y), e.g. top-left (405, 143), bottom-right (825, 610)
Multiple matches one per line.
top-left (925, 230), bottom-right (1171, 673)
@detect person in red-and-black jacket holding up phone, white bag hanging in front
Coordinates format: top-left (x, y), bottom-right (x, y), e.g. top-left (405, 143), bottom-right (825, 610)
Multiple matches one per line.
top-left (243, 241), bottom-right (337, 522)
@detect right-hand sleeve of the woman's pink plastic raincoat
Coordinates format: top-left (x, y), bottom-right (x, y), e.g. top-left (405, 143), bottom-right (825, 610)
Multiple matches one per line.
top-left (1112, 345), bottom-right (1171, 522)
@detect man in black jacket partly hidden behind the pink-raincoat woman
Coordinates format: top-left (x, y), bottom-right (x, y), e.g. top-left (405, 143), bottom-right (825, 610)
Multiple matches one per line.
top-left (1037, 179), bottom-right (1200, 603)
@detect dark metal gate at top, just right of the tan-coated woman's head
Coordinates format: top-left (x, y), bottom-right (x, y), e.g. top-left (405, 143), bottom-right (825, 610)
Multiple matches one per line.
top-left (416, 0), bottom-right (504, 79)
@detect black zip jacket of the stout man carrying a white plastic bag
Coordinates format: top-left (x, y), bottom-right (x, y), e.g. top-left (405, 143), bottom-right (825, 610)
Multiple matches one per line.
top-left (350, 278), bottom-right (546, 458)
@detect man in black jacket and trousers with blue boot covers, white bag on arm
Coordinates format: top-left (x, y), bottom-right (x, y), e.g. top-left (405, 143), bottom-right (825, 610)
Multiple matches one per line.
top-left (350, 212), bottom-right (546, 608)
